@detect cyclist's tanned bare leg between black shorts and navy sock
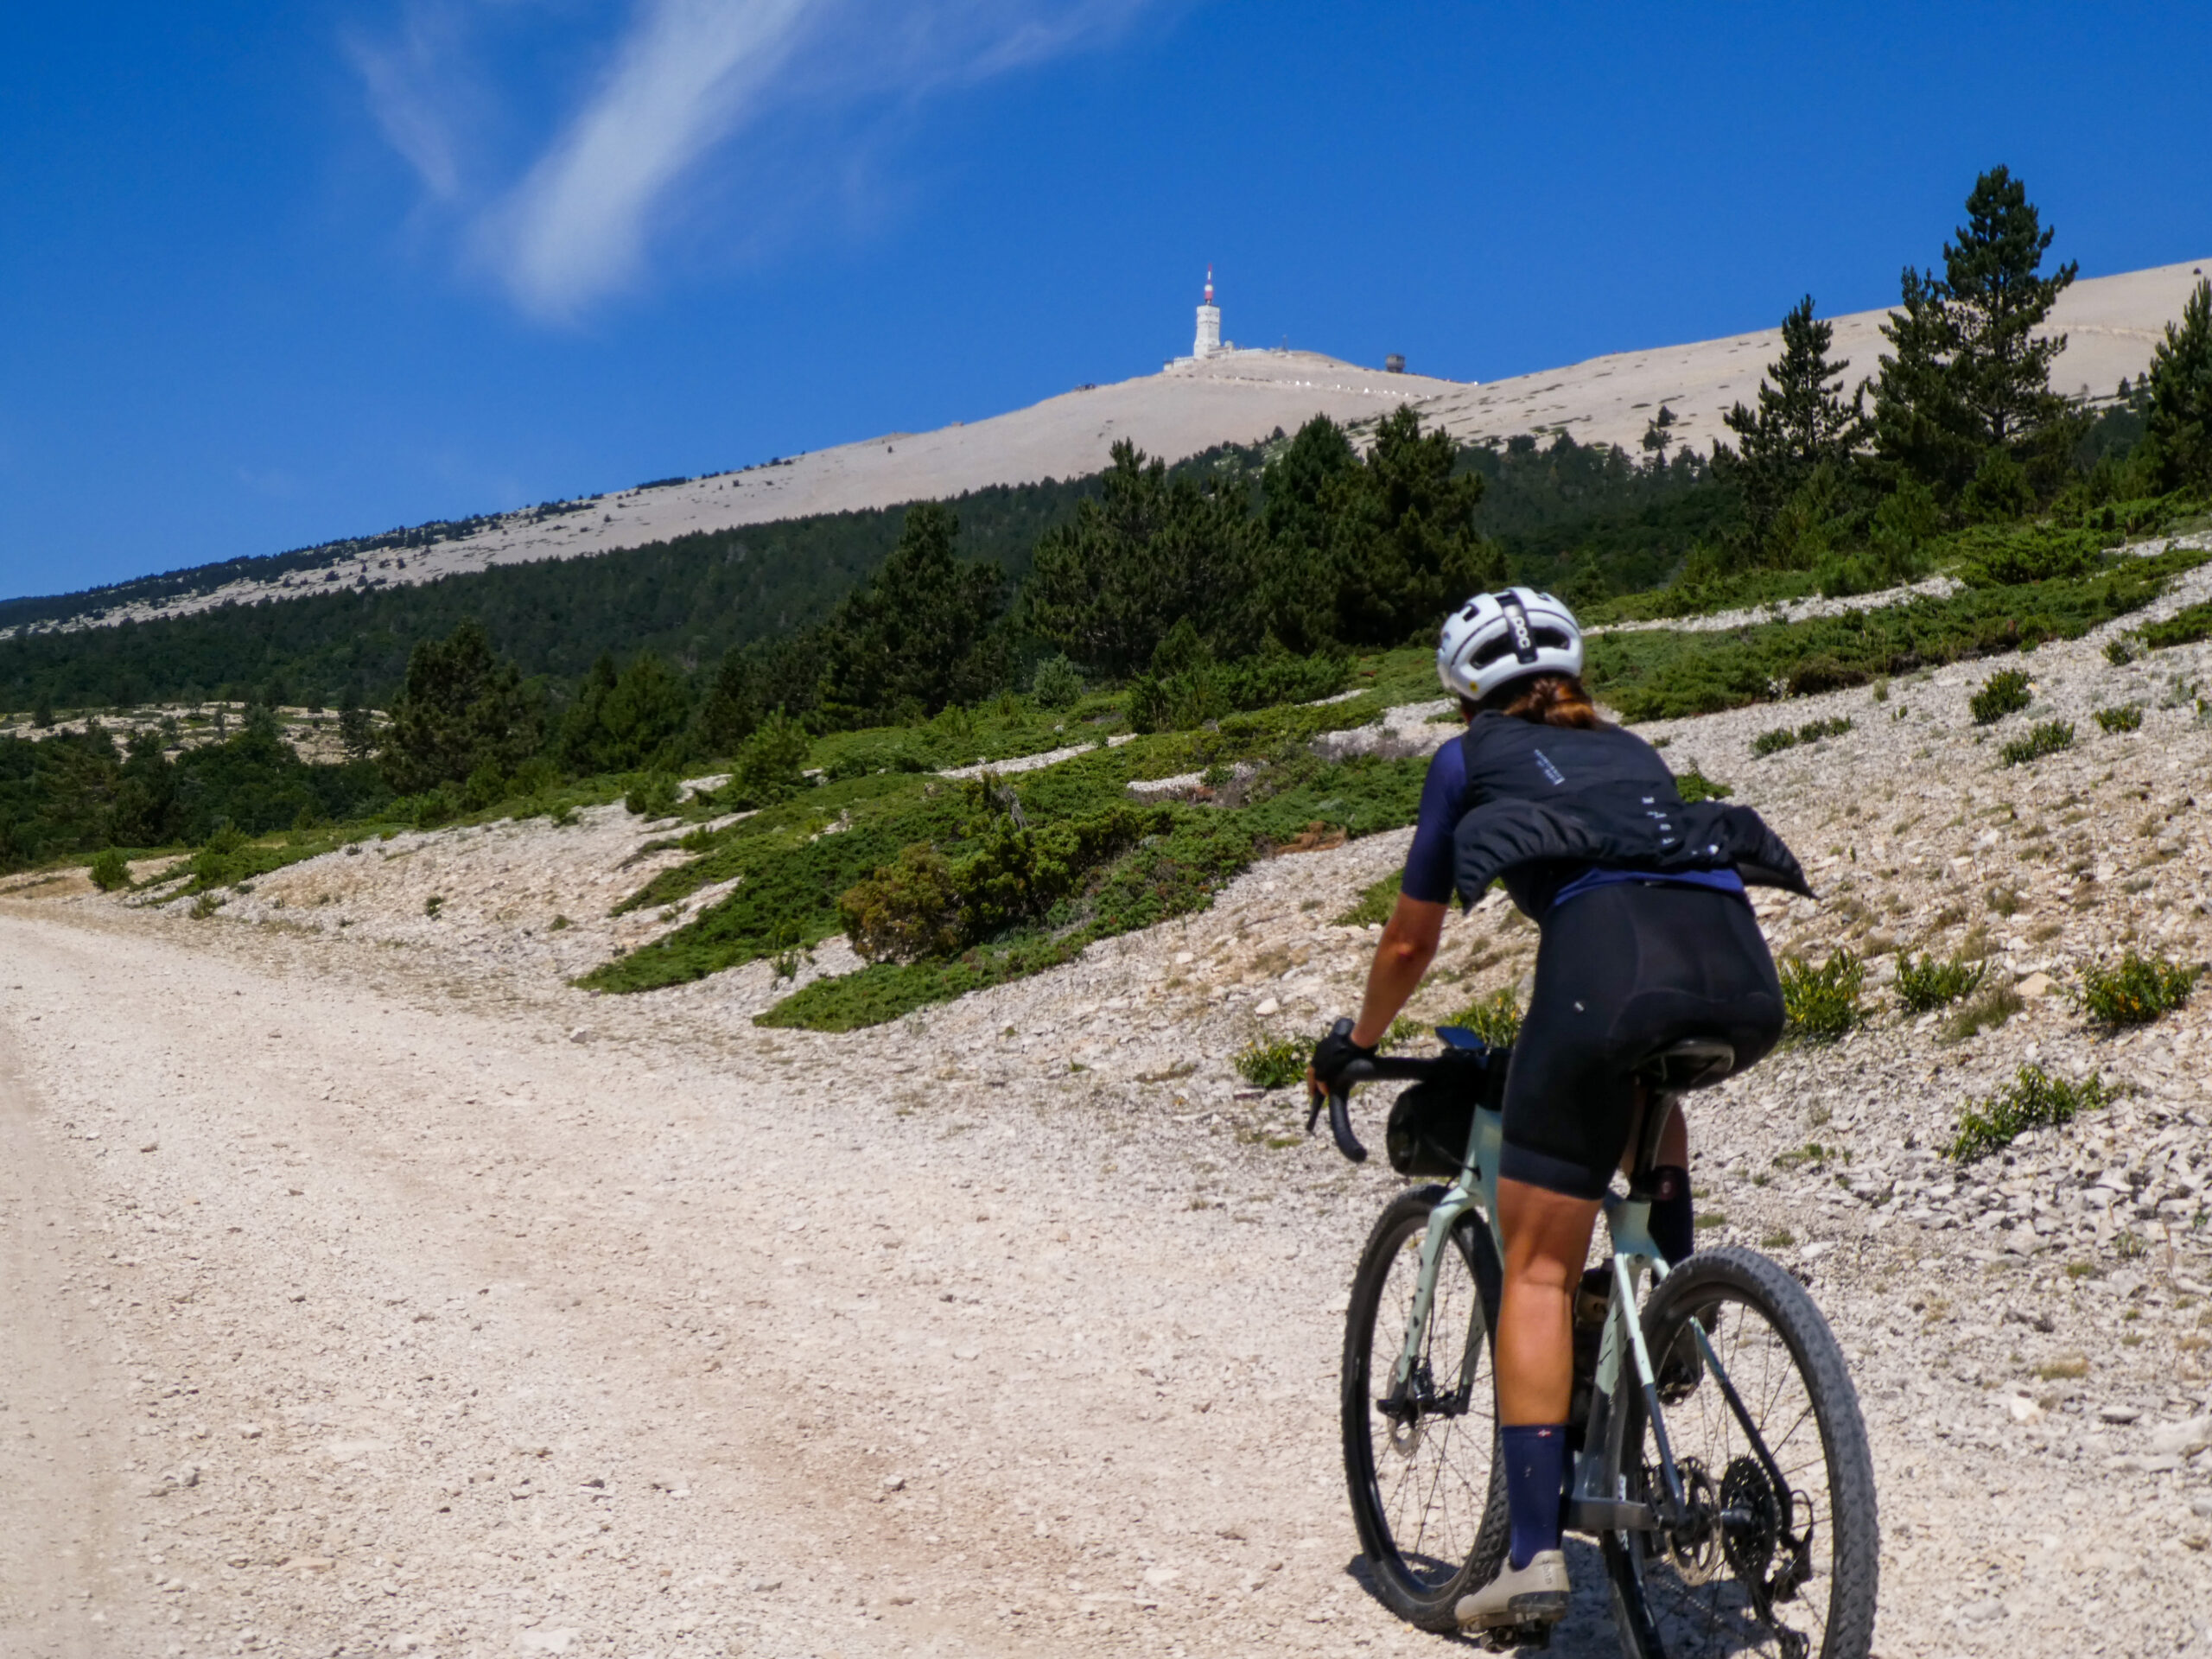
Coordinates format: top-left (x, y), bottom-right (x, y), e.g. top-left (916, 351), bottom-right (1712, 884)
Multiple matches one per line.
top-left (1497, 1179), bottom-right (1597, 1425)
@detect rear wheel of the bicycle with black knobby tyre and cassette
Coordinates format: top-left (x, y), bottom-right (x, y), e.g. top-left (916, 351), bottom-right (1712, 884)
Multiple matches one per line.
top-left (1606, 1249), bottom-right (1880, 1659)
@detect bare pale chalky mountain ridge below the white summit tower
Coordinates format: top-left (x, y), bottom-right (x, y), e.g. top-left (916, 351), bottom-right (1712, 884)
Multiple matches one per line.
top-left (17, 261), bottom-right (2205, 637)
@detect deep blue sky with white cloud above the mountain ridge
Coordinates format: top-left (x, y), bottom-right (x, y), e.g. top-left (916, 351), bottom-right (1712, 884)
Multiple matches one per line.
top-left (0, 0), bottom-right (2212, 595)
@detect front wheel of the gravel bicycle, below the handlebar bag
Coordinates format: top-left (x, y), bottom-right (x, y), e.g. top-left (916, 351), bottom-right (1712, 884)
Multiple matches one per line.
top-left (1343, 1185), bottom-right (1510, 1630)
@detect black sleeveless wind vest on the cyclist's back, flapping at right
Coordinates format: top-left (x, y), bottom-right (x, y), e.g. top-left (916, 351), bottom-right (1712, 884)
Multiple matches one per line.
top-left (1453, 710), bottom-right (1812, 920)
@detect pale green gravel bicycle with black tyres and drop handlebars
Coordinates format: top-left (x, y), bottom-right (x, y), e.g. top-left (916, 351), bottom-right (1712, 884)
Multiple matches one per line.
top-left (1305, 1022), bottom-right (1878, 1659)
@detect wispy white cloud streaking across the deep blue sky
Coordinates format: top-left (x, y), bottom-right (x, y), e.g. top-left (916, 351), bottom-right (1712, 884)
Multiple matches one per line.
top-left (354, 0), bottom-right (1157, 319)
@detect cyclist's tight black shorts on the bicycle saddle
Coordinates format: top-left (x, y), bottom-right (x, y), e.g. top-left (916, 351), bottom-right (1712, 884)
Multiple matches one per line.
top-left (1500, 882), bottom-right (1783, 1199)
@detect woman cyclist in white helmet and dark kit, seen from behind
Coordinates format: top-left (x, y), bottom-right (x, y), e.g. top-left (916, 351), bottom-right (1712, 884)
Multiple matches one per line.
top-left (1312, 588), bottom-right (1809, 1626)
